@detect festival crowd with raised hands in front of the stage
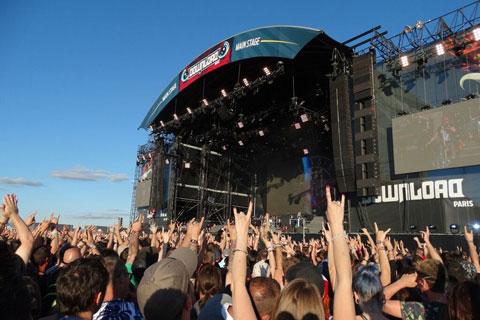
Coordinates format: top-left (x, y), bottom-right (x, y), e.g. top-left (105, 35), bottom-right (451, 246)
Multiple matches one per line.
top-left (0, 190), bottom-right (480, 320)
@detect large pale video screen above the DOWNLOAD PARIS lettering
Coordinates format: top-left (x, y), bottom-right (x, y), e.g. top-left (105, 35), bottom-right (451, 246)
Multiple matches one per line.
top-left (392, 99), bottom-right (480, 174)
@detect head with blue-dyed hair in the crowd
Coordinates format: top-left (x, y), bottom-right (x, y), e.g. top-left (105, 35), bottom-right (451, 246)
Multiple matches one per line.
top-left (353, 265), bottom-right (385, 315)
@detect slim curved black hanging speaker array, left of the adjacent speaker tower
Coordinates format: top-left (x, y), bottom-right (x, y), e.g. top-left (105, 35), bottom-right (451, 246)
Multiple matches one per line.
top-left (330, 73), bottom-right (355, 193)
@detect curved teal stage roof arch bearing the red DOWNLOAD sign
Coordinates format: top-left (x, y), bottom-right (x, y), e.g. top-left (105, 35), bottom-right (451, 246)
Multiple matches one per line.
top-left (139, 26), bottom-right (341, 129)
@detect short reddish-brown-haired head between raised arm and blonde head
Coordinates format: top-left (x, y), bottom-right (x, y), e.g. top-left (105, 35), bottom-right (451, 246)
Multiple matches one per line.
top-left (248, 277), bottom-right (280, 320)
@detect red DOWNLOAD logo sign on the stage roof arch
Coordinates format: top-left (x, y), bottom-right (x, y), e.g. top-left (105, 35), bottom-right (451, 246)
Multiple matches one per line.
top-left (180, 38), bottom-right (233, 91)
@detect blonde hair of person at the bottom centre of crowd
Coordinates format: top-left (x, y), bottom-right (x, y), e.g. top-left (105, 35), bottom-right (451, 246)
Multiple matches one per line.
top-left (273, 279), bottom-right (325, 320)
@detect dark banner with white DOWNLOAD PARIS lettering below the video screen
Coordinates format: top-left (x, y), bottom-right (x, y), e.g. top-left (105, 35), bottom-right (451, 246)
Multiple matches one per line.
top-left (351, 166), bottom-right (480, 233)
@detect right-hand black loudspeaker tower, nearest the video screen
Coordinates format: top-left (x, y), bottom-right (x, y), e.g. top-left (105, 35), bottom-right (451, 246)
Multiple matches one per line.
top-left (353, 53), bottom-right (380, 196)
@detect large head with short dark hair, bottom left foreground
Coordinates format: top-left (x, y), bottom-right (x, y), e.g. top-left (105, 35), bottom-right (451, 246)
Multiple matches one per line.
top-left (57, 257), bottom-right (109, 319)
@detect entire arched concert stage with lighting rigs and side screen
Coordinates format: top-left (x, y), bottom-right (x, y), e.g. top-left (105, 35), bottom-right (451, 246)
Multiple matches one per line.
top-left (131, 2), bottom-right (480, 233)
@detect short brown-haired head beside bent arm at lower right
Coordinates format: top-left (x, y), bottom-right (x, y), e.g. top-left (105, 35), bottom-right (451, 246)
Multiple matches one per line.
top-left (415, 259), bottom-right (447, 295)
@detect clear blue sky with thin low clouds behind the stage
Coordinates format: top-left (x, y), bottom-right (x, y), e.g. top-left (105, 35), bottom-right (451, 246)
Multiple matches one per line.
top-left (0, 0), bottom-right (471, 225)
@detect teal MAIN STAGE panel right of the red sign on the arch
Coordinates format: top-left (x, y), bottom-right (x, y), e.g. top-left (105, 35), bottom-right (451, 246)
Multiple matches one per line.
top-left (232, 26), bottom-right (321, 62)
